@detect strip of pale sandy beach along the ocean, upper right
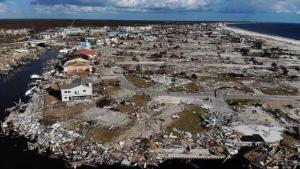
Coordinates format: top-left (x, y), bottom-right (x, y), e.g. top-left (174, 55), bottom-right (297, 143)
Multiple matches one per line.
top-left (223, 24), bottom-right (300, 45)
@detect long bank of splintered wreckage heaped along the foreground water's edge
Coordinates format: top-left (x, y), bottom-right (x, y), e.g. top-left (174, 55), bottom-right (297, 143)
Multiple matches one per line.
top-left (2, 90), bottom-right (299, 168)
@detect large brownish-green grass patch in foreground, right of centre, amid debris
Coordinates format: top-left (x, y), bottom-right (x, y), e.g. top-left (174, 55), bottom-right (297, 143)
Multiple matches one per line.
top-left (167, 105), bottom-right (208, 135)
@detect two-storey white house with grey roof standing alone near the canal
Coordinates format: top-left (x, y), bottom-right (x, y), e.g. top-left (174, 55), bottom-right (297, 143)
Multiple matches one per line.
top-left (60, 77), bottom-right (93, 102)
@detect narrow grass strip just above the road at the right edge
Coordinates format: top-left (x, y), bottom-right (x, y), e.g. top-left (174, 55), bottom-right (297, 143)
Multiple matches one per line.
top-left (261, 86), bottom-right (298, 96)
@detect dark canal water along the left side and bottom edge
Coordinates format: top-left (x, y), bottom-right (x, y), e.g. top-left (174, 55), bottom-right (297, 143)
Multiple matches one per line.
top-left (0, 49), bottom-right (243, 169)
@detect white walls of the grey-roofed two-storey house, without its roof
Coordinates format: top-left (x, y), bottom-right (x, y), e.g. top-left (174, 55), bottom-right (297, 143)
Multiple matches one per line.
top-left (61, 84), bottom-right (93, 102)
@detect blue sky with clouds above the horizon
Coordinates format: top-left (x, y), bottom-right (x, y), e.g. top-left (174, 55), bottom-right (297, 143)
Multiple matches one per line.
top-left (0, 0), bottom-right (300, 23)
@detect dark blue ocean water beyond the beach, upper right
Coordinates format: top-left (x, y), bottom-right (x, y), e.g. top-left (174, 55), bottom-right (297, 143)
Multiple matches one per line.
top-left (228, 23), bottom-right (300, 40)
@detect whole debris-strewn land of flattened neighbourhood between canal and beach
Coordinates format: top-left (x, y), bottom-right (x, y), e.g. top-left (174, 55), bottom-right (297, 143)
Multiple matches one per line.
top-left (0, 23), bottom-right (300, 168)
